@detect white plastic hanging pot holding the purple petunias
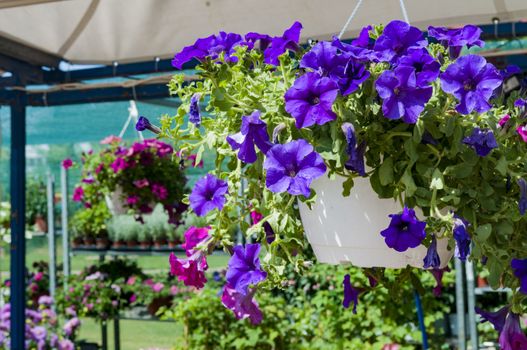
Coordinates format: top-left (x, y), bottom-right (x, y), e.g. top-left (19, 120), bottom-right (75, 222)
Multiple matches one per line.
top-left (299, 176), bottom-right (453, 268)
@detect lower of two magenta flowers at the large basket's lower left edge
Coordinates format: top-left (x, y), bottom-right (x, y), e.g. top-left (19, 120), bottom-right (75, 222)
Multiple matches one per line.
top-left (169, 252), bottom-right (208, 289)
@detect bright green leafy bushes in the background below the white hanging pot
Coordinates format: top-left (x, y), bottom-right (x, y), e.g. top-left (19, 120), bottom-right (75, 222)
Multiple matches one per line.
top-left (165, 265), bottom-right (452, 350)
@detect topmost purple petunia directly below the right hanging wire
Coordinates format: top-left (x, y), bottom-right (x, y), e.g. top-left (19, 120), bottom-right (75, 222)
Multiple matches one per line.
top-left (373, 20), bottom-right (427, 61)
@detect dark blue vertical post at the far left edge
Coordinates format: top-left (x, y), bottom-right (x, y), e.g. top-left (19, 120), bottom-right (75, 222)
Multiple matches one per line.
top-left (10, 91), bottom-right (26, 349)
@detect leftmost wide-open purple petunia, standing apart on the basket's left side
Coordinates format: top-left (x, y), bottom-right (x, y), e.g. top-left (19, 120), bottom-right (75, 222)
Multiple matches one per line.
top-left (189, 174), bottom-right (229, 216)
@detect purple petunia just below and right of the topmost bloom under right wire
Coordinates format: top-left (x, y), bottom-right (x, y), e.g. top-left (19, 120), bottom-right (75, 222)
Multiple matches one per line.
top-left (397, 48), bottom-right (441, 87)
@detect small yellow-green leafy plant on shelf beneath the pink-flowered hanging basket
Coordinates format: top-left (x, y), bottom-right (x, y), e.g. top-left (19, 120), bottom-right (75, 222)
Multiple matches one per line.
top-left (71, 202), bottom-right (111, 238)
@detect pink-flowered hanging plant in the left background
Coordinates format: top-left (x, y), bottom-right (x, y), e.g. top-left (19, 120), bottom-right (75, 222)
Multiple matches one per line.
top-left (68, 136), bottom-right (186, 223)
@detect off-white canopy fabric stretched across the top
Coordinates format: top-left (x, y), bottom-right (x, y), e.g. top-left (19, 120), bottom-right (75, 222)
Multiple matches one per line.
top-left (0, 0), bottom-right (527, 64)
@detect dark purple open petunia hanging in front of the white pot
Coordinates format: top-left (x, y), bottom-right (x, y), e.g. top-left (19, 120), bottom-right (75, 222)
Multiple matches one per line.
top-left (381, 206), bottom-right (426, 252)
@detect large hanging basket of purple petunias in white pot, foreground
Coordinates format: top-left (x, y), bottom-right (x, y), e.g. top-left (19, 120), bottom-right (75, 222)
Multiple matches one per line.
top-left (156, 21), bottom-right (527, 330)
